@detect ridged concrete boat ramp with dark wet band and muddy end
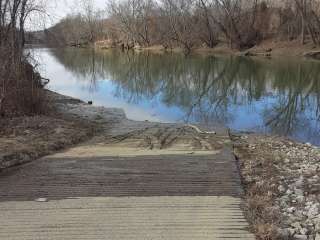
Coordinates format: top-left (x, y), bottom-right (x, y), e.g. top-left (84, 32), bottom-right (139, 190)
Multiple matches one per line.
top-left (0, 102), bottom-right (254, 240)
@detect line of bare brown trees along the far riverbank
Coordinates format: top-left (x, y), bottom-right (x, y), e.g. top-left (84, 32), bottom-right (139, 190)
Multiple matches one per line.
top-left (43, 0), bottom-right (320, 52)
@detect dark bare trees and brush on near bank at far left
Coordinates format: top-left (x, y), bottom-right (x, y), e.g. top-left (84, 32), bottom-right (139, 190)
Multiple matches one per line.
top-left (0, 0), bottom-right (46, 117)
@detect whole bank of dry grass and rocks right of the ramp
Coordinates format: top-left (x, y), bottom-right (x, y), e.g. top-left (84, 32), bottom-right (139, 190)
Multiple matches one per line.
top-left (232, 134), bottom-right (320, 240)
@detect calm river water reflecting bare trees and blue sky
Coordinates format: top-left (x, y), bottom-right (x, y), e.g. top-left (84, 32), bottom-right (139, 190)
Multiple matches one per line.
top-left (33, 49), bottom-right (320, 145)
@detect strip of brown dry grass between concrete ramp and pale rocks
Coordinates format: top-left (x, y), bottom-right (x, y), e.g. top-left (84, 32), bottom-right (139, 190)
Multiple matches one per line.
top-left (233, 136), bottom-right (281, 240)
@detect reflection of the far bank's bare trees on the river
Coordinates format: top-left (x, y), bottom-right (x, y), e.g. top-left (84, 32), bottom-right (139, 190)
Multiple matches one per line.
top-left (52, 49), bottom-right (320, 144)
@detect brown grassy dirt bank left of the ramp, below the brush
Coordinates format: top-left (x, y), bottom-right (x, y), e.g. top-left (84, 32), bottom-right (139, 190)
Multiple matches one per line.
top-left (0, 92), bottom-right (95, 171)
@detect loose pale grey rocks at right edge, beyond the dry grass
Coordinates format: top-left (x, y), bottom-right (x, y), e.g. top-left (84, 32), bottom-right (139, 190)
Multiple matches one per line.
top-left (275, 142), bottom-right (320, 240)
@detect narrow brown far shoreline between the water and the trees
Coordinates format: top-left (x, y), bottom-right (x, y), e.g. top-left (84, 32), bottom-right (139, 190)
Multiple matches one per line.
top-left (26, 40), bottom-right (320, 61)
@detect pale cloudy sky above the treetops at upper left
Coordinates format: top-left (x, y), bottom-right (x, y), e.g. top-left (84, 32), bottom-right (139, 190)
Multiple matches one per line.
top-left (27, 0), bottom-right (107, 30)
